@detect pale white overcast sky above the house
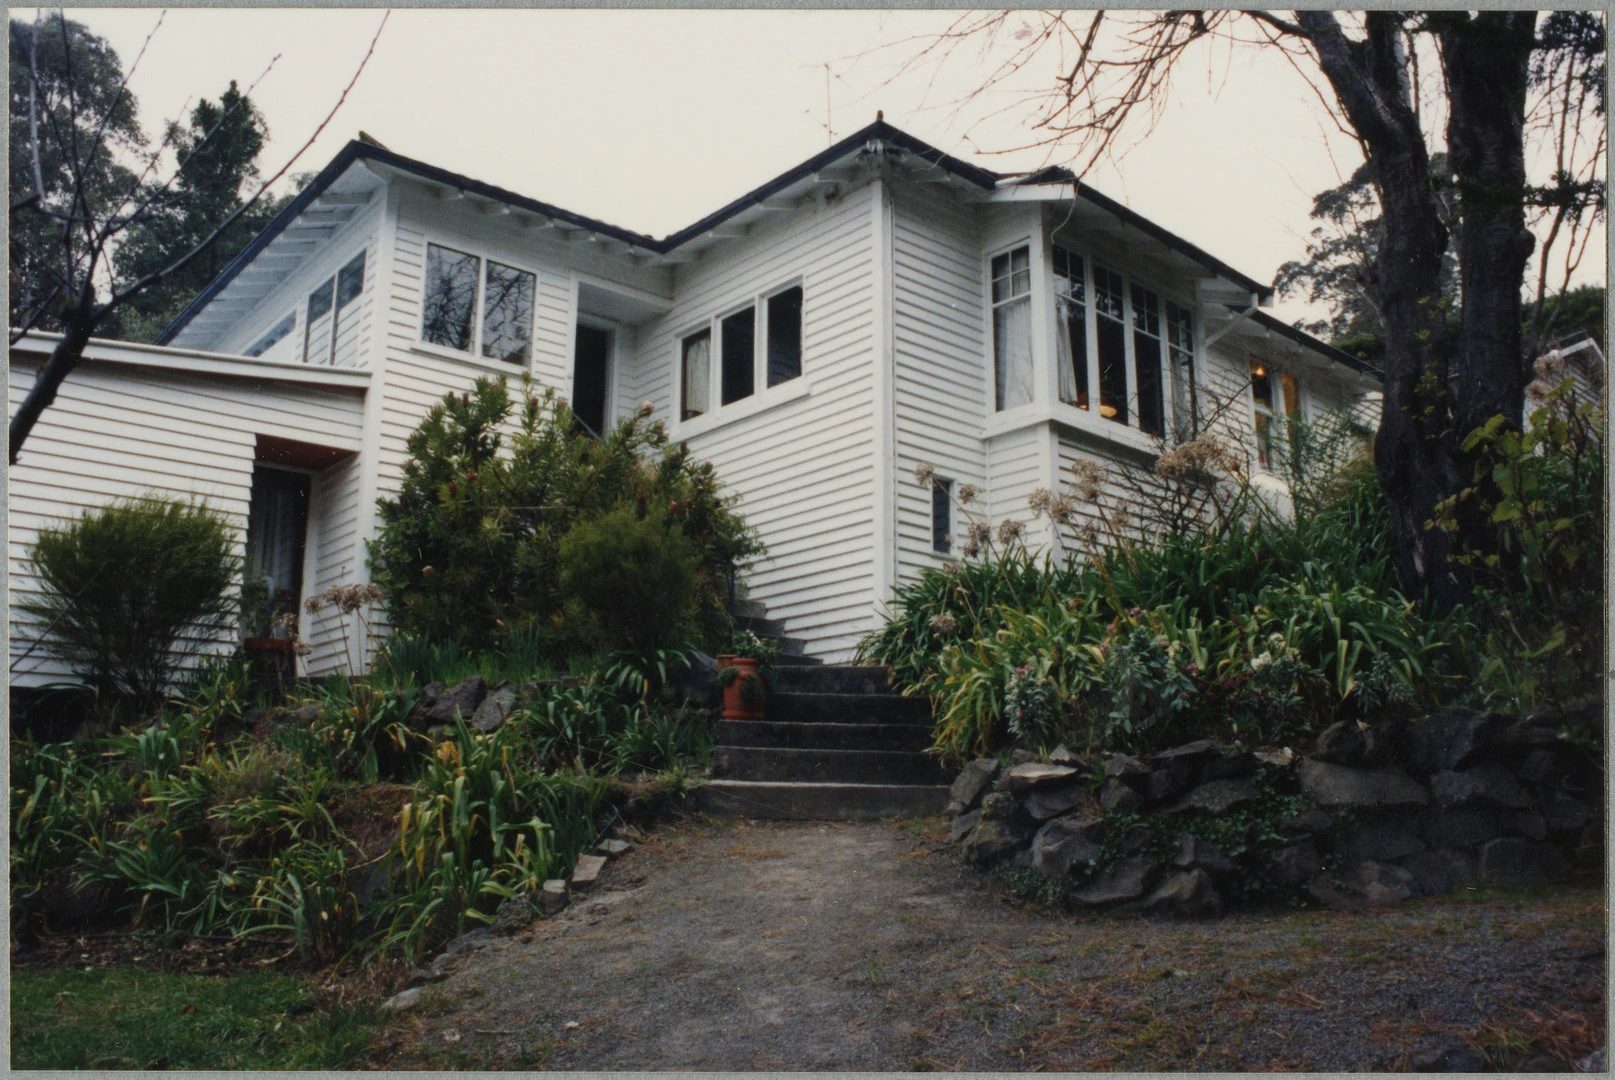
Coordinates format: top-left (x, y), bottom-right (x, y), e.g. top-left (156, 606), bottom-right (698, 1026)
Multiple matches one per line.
top-left (47, 8), bottom-right (1604, 320)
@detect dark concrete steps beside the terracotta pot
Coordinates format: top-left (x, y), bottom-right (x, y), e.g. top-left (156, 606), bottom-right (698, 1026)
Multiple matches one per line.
top-left (701, 632), bottom-right (948, 820)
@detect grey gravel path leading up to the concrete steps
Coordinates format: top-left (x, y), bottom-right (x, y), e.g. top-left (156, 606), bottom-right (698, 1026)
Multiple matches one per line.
top-left (373, 822), bottom-right (1605, 1070)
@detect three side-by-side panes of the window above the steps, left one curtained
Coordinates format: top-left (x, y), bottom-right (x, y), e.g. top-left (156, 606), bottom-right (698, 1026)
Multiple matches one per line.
top-left (678, 286), bottom-right (803, 420)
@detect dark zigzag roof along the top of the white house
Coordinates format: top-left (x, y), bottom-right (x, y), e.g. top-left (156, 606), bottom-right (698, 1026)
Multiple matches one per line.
top-left (157, 119), bottom-right (1272, 344)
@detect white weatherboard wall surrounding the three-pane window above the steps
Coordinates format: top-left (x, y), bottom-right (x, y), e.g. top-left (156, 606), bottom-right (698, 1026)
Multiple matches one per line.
top-left (627, 186), bottom-right (879, 660)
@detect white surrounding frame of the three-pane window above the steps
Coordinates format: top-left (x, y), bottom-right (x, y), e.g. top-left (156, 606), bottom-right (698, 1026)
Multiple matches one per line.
top-left (669, 274), bottom-right (809, 437)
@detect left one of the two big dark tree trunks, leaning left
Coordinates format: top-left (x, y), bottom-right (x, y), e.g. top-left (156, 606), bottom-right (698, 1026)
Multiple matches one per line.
top-left (1295, 11), bottom-right (1466, 609)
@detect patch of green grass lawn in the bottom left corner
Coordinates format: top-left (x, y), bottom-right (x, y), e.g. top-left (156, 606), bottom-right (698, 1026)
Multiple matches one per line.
top-left (11, 967), bottom-right (383, 1069)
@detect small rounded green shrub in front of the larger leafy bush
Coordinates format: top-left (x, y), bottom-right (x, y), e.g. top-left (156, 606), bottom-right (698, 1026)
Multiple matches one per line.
top-left (557, 504), bottom-right (698, 652)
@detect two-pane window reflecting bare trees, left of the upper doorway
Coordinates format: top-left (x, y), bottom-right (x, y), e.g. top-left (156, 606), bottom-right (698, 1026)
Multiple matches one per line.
top-left (420, 244), bottom-right (538, 368)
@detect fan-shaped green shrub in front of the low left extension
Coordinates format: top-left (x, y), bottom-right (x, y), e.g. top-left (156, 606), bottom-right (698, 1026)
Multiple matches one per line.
top-left (18, 499), bottom-right (239, 710)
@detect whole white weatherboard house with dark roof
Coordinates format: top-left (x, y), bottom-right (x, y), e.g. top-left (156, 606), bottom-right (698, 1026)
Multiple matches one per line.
top-left (10, 121), bottom-right (1378, 684)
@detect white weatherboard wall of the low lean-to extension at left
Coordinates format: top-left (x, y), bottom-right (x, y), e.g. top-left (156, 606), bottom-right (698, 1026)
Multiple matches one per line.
top-left (6, 354), bottom-right (363, 686)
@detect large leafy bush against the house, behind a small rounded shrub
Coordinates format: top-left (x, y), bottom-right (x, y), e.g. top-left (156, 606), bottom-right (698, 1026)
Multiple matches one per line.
top-left (371, 378), bottom-right (761, 652)
